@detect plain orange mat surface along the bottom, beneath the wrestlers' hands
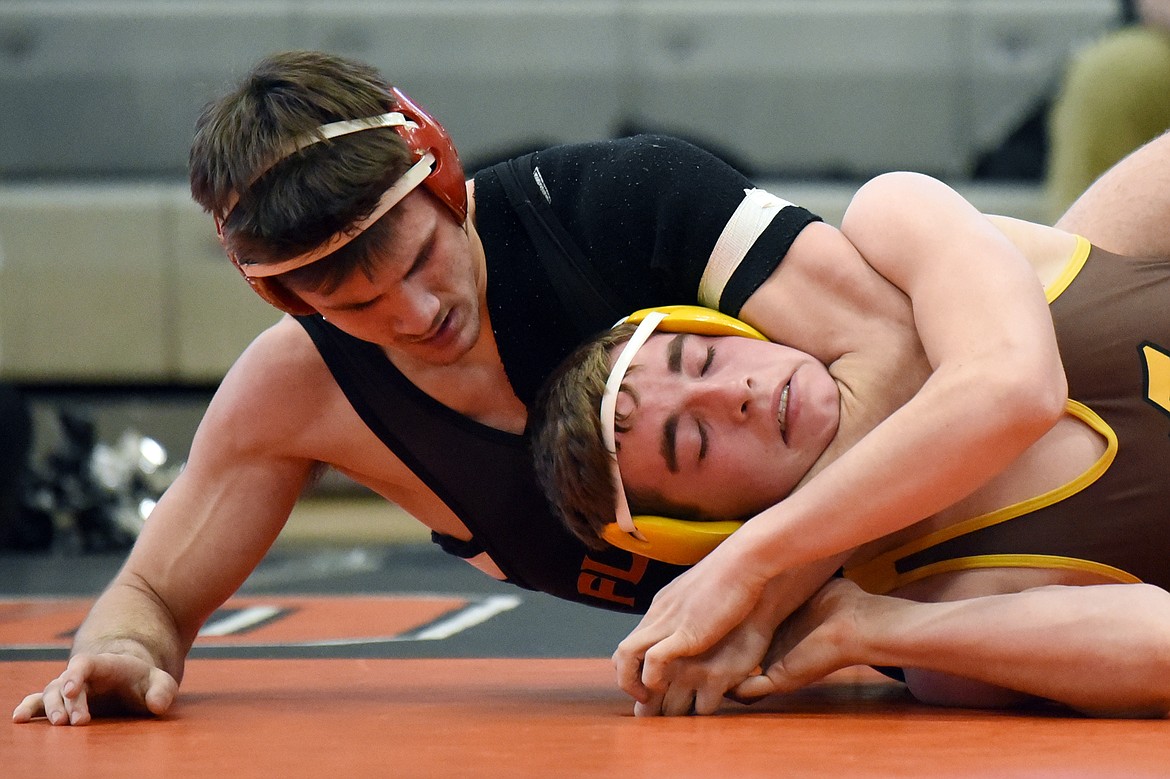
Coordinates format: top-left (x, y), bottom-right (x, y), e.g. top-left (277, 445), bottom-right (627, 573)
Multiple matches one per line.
top-left (0, 659), bottom-right (1170, 779)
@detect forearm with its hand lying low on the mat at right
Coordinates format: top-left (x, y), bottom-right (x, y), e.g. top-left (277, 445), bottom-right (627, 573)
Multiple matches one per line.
top-left (738, 580), bottom-right (1170, 717)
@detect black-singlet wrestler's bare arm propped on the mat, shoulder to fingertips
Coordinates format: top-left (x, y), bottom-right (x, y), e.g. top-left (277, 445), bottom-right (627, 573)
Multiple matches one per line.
top-left (14, 325), bottom-right (314, 724)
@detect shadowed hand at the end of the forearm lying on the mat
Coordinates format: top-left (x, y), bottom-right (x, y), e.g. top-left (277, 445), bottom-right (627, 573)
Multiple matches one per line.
top-left (730, 579), bottom-right (876, 701)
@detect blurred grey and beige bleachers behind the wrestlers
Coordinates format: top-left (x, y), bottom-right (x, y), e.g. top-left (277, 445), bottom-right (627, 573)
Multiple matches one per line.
top-left (0, 0), bottom-right (1119, 545)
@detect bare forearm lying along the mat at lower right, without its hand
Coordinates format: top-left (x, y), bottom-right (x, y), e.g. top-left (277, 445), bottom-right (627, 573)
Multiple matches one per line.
top-left (848, 585), bottom-right (1170, 716)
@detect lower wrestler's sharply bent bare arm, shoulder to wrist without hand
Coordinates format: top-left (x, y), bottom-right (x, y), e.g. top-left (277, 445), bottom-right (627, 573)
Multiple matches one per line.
top-left (736, 174), bottom-right (1067, 563)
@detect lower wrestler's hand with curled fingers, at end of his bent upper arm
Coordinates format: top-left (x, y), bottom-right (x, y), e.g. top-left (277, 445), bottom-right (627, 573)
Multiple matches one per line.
top-left (613, 542), bottom-right (767, 712)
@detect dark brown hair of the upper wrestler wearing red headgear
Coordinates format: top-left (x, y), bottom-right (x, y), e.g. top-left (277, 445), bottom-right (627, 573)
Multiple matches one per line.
top-left (190, 51), bottom-right (411, 288)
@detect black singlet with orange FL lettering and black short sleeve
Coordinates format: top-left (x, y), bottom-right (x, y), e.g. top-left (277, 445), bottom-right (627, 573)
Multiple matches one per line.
top-left (298, 136), bottom-right (817, 612)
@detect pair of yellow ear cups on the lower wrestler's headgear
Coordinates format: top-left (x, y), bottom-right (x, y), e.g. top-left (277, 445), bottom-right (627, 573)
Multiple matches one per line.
top-left (601, 305), bottom-right (768, 565)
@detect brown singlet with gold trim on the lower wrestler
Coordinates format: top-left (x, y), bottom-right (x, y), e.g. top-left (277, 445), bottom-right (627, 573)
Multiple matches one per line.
top-left (845, 240), bottom-right (1170, 593)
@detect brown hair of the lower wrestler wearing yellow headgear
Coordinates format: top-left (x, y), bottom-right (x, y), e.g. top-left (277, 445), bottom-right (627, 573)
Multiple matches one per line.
top-left (529, 324), bottom-right (709, 549)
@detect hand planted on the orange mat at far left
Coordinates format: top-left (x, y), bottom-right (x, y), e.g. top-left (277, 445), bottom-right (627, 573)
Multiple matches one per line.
top-left (12, 654), bottom-right (179, 725)
